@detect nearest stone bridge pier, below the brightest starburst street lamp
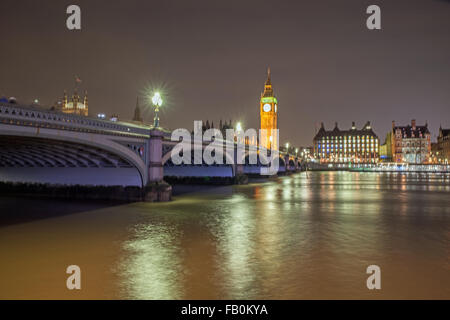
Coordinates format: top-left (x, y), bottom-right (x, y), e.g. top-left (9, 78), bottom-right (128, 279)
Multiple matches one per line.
top-left (143, 129), bottom-right (172, 202)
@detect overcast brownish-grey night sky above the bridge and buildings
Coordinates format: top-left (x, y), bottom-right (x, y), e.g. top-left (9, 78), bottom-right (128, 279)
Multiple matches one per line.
top-left (0, 0), bottom-right (450, 146)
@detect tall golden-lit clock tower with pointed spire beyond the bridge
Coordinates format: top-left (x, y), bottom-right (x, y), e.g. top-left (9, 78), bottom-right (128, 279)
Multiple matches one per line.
top-left (260, 68), bottom-right (278, 150)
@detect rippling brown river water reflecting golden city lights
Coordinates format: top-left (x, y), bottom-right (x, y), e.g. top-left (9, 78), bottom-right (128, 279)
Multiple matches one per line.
top-left (0, 172), bottom-right (450, 299)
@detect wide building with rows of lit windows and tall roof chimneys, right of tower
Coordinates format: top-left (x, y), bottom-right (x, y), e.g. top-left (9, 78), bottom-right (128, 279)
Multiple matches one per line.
top-left (313, 121), bottom-right (380, 163)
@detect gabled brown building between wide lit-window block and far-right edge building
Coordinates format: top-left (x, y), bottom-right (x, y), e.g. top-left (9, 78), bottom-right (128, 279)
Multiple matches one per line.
top-left (388, 120), bottom-right (431, 163)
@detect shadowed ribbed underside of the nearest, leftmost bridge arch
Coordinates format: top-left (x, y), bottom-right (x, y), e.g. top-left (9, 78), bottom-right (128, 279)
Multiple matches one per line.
top-left (0, 136), bottom-right (142, 187)
